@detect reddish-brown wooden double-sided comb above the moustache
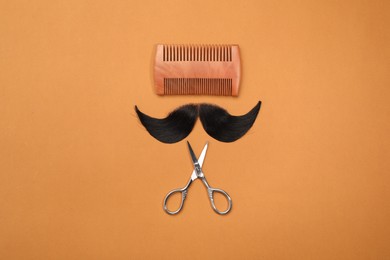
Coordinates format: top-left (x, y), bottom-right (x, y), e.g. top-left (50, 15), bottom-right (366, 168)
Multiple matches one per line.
top-left (154, 44), bottom-right (241, 96)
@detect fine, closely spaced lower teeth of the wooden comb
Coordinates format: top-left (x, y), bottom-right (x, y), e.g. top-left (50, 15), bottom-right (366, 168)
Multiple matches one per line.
top-left (164, 78), bottom-right (232, 96)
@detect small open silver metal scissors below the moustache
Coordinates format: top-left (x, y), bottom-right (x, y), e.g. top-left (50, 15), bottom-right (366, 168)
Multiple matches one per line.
top-left (164, 141), bottom-right (232, 215)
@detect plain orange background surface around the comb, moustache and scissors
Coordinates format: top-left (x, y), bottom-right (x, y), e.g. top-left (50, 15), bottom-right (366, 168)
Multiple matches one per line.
top-left (0, 0), bottom-right (390, 259)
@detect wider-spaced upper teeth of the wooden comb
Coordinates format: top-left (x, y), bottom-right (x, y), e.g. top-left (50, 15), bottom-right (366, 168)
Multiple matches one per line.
top-left (163, 45), bottom-right (232, 62)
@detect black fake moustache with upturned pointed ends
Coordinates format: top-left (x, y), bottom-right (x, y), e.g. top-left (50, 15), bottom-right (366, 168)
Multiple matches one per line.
top-left (135, 101), bottom-right (261, 144)
